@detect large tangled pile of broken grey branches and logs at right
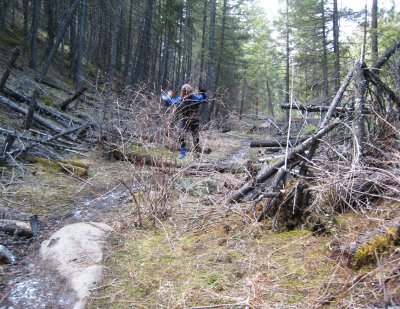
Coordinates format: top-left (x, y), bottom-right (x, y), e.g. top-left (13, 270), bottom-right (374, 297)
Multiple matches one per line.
top-left (229, 43), bottom-right (400, 228)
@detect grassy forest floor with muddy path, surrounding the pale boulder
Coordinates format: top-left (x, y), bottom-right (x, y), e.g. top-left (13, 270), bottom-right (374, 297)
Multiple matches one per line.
top-left (1, 123), bottom-right (399, 308)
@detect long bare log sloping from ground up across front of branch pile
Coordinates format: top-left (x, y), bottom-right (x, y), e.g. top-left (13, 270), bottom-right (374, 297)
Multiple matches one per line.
top-left (228, 121), bottom-right (339, 202)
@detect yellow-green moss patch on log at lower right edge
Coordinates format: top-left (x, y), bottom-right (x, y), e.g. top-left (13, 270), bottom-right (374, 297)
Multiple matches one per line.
top-left (353, 228), bottom-right (399, 268)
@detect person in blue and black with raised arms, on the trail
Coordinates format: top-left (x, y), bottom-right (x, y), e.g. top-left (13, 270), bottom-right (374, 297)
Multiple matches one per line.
top-left (162, 84), bottom-right (208, 159)
